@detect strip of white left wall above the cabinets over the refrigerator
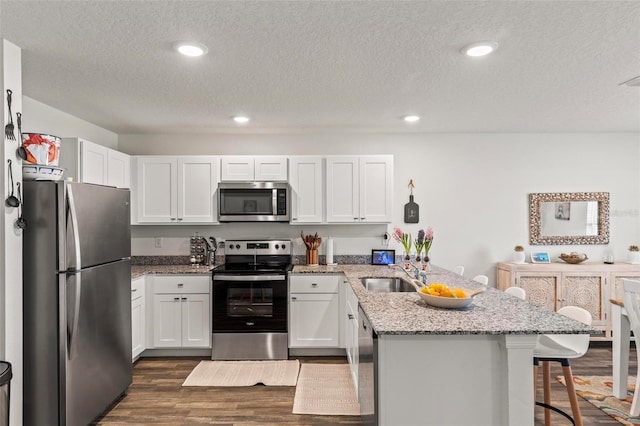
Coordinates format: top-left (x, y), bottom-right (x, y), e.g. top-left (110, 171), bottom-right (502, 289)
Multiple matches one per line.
top-left (22, 96), bottom-right (118, 149)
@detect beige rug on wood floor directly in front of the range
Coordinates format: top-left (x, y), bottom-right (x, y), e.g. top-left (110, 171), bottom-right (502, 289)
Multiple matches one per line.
top-left (182, 359), bottom-right (300, 386)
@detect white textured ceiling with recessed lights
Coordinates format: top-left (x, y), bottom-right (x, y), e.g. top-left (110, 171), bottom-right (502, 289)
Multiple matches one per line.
top-left (0, 0), bottom-right (640, 133)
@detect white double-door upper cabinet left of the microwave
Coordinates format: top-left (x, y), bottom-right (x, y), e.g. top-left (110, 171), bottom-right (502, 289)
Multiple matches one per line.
top-left (132, 155), bottom-right (219, 224)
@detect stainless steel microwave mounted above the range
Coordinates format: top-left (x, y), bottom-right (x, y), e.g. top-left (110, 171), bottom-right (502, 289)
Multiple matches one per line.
top-left (218, 182), bottom-right (291, 222)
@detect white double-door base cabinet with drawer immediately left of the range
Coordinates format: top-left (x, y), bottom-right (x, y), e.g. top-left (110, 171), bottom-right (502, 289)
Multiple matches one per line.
top-left (150, 275), bottom-right (211, 348)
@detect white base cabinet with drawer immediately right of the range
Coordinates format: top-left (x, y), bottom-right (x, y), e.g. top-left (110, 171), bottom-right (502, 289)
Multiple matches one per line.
top-left (289, 274), bottom-right (342, 348)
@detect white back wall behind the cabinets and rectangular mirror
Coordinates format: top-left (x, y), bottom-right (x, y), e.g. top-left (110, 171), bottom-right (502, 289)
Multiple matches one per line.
top-left (119, 132), bottom-right (640, 284)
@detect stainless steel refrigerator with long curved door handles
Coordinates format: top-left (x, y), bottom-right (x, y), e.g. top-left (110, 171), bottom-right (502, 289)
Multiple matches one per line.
top-left (23, 181), bottom-right (132, 426)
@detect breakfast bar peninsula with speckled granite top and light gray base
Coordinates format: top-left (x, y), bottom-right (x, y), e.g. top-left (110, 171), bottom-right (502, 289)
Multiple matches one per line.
top-left (291, 265), bottom-right (594, 426)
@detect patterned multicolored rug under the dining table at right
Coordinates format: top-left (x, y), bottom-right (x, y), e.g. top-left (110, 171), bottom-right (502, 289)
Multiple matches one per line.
top-left (556, 376), bottom-right (640, 426)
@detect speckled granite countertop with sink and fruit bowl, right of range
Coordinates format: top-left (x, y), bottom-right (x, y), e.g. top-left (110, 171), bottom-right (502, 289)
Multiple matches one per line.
top-left (292, 265), bottom-right (599, 335)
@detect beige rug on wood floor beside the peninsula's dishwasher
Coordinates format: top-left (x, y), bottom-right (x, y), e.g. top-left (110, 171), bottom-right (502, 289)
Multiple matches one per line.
top-left (293, 364), bottom-right (360, 416)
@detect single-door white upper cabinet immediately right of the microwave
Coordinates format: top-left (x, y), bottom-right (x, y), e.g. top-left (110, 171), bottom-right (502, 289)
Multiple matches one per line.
top-left (289, 156), bottom-right (324, 224)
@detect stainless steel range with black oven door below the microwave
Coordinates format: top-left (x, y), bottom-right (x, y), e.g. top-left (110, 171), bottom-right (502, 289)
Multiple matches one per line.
top-left (211, 240), bottom-right (292, 360)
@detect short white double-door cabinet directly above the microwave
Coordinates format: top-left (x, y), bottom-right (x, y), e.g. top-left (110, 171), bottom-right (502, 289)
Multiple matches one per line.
top-left (221, 155), bottom-right (287, 182)
